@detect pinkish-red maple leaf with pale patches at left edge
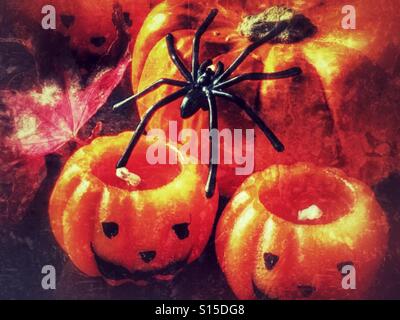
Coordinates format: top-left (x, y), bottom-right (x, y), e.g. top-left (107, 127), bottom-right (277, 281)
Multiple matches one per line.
top-left (2, 57), bottom-right (129, 156)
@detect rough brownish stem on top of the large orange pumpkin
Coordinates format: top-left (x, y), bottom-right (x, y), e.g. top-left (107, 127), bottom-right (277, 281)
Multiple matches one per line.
top-left (238, 5), bottom-right (317, 43)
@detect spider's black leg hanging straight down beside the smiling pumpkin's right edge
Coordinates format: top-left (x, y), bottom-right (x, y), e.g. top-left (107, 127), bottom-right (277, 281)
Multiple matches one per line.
top-left (205, 91), bottom-right (219, 198)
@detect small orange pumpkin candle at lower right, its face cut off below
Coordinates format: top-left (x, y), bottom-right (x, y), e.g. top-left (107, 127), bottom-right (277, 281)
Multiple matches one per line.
top-left (216, 164), bottom-right (388, 299)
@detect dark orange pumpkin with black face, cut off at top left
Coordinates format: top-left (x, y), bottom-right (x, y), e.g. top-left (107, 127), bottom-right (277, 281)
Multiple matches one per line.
top-left (16, 0), bottom-right (161, 54)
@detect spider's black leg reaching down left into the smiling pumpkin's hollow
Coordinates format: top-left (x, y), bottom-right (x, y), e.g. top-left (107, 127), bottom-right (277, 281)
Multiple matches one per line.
top-left (116, 88), bottom-right (187, 169)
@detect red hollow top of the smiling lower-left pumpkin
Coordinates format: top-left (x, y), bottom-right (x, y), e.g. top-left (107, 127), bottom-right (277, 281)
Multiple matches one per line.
top-left (92, 143), bottom-right (182, 191)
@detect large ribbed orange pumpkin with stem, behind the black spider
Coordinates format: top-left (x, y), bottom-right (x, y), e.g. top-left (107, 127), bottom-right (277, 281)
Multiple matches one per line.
top-left (132, 0), bottom-right (400, 194)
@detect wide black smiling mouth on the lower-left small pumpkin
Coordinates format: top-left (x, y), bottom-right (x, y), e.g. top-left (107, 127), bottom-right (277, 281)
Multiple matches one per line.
top-left (90, 244), bottom-right (188, 281)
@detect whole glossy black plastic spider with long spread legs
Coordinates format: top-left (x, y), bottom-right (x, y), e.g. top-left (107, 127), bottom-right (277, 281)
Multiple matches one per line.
top-left (114, 9), bottom-right (301, 198)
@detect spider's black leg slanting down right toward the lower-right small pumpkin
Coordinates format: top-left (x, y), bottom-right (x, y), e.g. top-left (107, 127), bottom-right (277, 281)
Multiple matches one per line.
top-left (212, 90), bottom-right (285, 152)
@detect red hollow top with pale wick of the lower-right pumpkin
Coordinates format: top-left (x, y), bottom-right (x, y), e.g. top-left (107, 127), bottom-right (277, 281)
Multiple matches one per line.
top-left (260, 171), bottom-right (353, 224)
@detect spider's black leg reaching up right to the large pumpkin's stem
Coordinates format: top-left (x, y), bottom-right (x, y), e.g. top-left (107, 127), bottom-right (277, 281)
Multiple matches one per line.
top-left (215, 21), bottom-right (288, 83)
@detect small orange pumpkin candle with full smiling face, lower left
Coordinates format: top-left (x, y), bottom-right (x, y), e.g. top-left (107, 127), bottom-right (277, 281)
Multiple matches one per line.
top-left (49, 132), bottom-right (218, 285)
